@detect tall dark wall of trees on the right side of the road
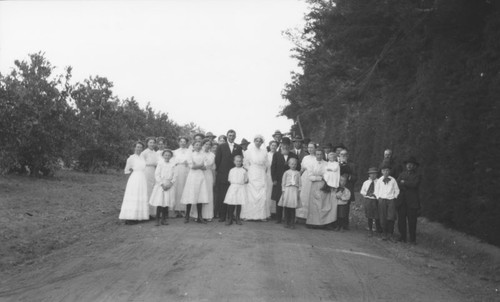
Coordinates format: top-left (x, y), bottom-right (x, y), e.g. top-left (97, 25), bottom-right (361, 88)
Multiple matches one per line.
top-left (282, 0), bottom-right (500, 245)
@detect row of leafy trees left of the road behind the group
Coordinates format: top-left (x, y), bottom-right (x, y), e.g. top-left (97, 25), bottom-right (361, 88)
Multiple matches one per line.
top-left (0, 53), bottom-right (200, 175)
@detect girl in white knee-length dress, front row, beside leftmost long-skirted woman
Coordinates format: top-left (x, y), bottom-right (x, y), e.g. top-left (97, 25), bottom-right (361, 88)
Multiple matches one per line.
top-left (149, 149), bottom-right (177, 226)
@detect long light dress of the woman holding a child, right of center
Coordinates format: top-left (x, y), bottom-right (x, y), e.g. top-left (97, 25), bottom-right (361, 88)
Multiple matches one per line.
top-left (306, 160), bottom-right (337, 226)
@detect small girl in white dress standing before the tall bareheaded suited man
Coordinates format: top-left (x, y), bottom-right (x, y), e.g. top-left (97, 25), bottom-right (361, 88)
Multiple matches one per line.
top-left (224, 155), bottom-right (248, 225)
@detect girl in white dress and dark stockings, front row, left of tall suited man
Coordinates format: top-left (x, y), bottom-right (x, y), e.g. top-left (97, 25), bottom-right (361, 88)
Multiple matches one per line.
top-left (181, 141), bottom-right (209, 223)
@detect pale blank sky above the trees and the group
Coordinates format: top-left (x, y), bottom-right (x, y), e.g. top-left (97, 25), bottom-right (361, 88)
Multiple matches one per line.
top-left (0, 0), bottom-right (307, 142)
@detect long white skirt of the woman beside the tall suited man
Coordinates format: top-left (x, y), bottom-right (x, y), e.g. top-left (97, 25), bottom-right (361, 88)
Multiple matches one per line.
top-left (241, 165), bottom-right (269, 220)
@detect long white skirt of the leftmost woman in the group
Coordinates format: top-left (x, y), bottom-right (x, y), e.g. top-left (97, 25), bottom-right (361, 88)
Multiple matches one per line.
top-left (118, 171), bottom-right (149, 220)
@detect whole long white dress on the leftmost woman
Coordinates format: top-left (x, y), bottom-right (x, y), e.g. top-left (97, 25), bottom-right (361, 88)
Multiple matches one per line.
top-left (118, 154), bottom-right (149, 220)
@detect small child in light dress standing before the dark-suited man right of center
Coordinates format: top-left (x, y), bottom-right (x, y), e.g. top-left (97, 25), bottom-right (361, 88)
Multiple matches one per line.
top-left (278, 158), bottom-right (302, 229)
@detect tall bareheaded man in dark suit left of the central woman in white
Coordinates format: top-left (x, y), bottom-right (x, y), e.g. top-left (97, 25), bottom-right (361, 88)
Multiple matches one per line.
top-left (214, 129), bottom-right (243, 222)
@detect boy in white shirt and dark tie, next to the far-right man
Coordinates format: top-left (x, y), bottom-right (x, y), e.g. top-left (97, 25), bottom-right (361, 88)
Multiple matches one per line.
top-left (374, 165), bottom-right (399, 241)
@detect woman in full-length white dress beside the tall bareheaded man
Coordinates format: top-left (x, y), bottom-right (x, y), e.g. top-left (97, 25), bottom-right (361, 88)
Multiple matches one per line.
top-left (241, 135), bottom-right (269, 221)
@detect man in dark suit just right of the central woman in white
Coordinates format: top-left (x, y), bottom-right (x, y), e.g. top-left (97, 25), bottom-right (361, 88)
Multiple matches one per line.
top-left (271, 137), bottom-right (300, 223)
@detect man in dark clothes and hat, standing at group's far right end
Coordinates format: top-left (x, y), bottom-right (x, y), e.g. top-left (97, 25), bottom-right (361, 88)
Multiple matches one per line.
top-left (397, 156), bottom-right (421, 244)
